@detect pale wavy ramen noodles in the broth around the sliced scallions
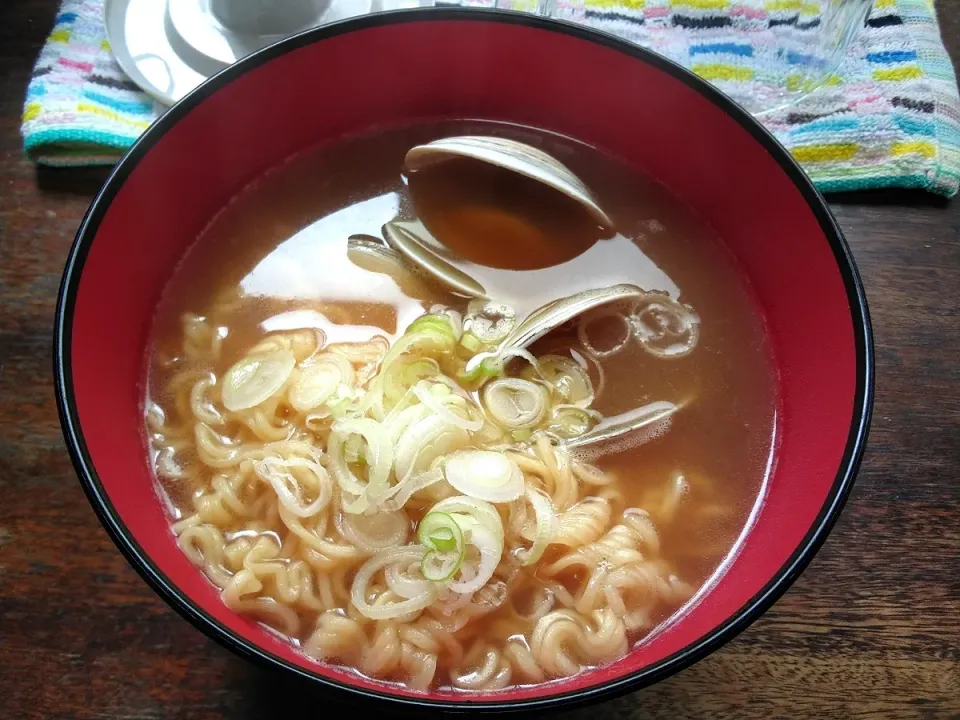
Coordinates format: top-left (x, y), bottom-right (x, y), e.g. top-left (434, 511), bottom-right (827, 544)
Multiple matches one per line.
top-left (152, 311), bottom-right (720, 691)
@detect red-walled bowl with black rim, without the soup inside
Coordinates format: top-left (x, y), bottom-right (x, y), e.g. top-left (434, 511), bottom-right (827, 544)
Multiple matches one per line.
top-left (55, 10), bottom-right (873, 710)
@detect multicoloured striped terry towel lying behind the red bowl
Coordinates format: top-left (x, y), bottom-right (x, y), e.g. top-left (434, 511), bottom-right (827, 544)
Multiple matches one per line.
top-left (23, 0), bottom-right (960, 197)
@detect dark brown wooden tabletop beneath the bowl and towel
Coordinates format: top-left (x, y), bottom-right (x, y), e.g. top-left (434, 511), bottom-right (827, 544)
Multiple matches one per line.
top-left (0, 0), bottom-right (960, 720)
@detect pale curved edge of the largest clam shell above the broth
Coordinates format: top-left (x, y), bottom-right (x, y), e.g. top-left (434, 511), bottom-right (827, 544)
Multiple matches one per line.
top-left (404, 135), bottom-right (613, 228)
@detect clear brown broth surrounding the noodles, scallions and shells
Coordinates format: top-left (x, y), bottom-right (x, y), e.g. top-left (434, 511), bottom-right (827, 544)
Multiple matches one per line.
top-left (147, 122), bottom-right (777, 686)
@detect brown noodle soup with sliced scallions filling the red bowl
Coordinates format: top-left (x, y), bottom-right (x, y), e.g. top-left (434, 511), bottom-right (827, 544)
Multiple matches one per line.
top-left (146, 122), bottom-right (776, 691)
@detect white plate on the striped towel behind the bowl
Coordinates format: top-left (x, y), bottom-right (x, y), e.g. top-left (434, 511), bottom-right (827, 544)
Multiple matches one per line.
top-left (103, 0), bottom-right (434, 105)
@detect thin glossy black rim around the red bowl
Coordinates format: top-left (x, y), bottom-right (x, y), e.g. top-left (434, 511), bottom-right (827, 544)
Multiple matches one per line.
top-left (54, 8), bottom-right (874, 712)
